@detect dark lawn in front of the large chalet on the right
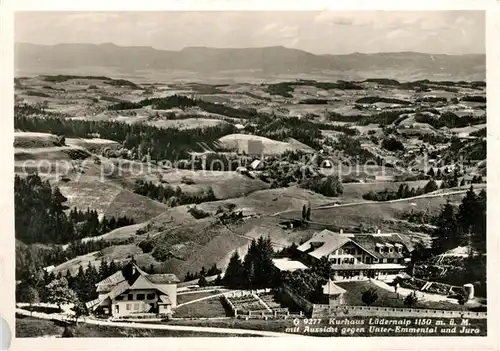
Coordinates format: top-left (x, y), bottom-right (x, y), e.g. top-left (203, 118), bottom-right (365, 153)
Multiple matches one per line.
top-left (335, 281), bottom-right (468, 310)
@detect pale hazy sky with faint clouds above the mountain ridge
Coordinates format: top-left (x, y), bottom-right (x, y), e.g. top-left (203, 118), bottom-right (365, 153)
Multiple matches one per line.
top-left (15, 11), bottom-right (485, 54)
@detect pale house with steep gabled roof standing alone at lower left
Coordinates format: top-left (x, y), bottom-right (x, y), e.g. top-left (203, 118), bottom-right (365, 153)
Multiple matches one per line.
top-left (86, 261), bottom-right (179, 317)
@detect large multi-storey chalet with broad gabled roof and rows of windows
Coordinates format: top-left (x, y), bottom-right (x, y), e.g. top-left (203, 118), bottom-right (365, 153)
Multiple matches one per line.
top-left (297, 229), bottom-right (413, 280)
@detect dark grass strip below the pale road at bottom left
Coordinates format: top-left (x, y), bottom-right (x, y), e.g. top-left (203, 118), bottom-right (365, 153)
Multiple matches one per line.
top-left (16, 316), bottom-right (255, 338)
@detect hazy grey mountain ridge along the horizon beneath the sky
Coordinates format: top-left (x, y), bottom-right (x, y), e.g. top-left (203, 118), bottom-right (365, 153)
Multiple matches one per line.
top-left (15, 43), bottom-right (486, 80)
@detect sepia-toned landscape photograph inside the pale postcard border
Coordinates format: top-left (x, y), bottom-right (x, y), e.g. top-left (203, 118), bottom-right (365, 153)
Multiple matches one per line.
top-left (2, 5), bottom-right (494, 347)
